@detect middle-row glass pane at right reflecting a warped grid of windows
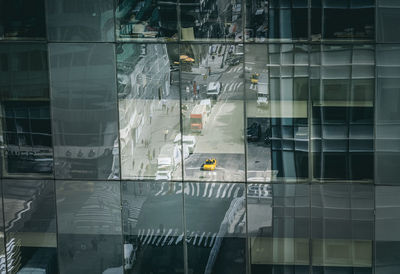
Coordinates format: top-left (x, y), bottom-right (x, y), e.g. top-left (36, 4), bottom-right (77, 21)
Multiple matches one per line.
top-left (311, 45), bottom-right (375, 180)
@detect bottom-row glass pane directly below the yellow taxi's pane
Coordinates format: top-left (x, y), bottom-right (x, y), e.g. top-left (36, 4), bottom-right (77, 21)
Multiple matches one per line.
top-left (184, 182), bottom-right (246, 273)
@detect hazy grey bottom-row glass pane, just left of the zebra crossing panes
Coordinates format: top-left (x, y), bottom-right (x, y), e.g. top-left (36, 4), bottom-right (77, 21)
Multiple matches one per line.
top-left (56, 181), bottom-right (124, 274)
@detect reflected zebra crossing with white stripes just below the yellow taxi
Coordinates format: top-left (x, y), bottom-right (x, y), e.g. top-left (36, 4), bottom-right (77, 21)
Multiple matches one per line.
top-left (154, 182), bottom-right (244, 199)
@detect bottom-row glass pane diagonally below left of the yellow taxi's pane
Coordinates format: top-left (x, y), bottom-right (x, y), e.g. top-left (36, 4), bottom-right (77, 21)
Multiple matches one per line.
top-left (121, 181), bottom-right (184, 274)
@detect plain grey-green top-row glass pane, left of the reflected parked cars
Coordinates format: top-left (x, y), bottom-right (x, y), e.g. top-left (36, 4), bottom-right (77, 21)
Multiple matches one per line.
top-left (46, 0), bottom-right (115, 42)
